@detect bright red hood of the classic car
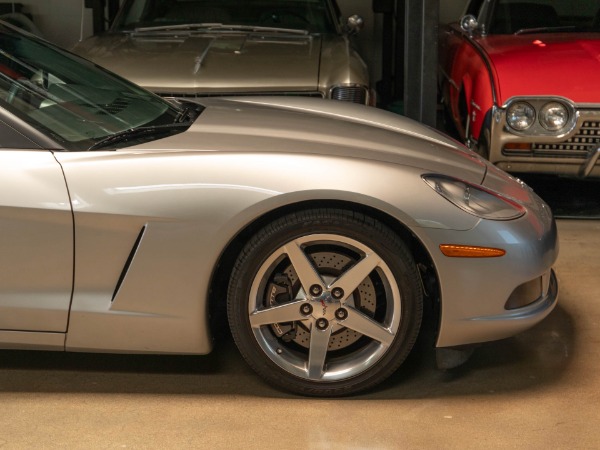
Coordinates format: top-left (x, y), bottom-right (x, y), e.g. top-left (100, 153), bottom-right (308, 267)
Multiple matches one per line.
top-left (479, 33), bottom-right (600, 105)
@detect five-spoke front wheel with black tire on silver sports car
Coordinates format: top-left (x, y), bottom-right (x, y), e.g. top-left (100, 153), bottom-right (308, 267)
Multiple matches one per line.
top-left (228, 210), bottom-right (423, 396)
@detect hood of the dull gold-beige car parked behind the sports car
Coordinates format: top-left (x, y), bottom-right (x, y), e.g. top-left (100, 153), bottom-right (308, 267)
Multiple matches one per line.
top-left (73, 32), bottom-right (322, 95)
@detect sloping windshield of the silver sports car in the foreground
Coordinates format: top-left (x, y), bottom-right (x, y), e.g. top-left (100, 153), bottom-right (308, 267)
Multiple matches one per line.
top-left (0, 24), bottom-right (182, 149)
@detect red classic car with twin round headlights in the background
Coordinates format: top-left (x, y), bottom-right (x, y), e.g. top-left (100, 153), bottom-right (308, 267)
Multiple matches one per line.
top-left (440, 0), bottom-right (600, 176)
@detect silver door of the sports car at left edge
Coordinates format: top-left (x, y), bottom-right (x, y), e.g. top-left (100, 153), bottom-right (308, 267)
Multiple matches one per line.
top-left (0, 125), bottom-right (73, 332)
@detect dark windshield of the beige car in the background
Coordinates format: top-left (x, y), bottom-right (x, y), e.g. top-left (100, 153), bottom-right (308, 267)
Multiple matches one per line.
top-left (112, 0), bottom-right (337, 33)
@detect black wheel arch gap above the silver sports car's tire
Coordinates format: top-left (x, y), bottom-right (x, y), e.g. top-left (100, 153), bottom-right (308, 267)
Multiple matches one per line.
top-left (208, 200), bottom-right (440, 337)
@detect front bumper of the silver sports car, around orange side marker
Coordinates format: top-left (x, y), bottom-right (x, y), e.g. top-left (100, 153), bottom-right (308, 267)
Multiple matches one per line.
top-left (414, 183), bottom-right (558, 347)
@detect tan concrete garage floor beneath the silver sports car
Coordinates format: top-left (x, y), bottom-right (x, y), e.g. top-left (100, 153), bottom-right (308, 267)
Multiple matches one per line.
top-left (0, 220), bottom-right (600, 449)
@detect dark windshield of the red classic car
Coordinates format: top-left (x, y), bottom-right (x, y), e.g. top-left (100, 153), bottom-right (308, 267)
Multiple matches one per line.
top-left (489, 0), bottom-right (600, 34)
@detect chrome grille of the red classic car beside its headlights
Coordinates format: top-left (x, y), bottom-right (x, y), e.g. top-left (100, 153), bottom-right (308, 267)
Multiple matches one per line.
top-left (533, 120), bottom-right (600, 158)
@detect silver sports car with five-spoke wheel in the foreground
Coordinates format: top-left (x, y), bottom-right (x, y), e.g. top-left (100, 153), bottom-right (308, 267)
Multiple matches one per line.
top-left (0, 24), bottom-right (558, 396)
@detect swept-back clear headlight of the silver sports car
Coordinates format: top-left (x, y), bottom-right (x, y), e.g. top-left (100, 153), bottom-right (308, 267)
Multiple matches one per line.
top-left (423, 175), bottom-right (525, 220)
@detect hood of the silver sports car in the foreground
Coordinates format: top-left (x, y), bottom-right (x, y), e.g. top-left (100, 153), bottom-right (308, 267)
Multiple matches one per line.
top-left (139, 97), bottom-right (487, 183)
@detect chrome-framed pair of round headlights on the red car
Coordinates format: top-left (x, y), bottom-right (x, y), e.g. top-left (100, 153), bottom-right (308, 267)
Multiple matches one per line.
top-left (502, 97), bottom-right (578, 137)
